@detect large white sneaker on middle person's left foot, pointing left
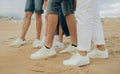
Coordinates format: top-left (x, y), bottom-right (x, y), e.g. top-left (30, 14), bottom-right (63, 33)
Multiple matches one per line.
top-left (30, 46), bottom-right (56, 59)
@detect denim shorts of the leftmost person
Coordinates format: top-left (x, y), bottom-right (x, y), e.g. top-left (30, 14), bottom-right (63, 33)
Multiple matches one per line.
top-left (25, 0), bottom-right (44, 14)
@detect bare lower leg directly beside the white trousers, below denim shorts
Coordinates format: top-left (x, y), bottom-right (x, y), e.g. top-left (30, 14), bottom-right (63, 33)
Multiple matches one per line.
top-left (66, 14), bottom-right (77, 45)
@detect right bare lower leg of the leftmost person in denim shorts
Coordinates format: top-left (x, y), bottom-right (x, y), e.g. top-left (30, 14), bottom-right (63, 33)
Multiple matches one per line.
top-left (36, 13), bottom-right (42, 39)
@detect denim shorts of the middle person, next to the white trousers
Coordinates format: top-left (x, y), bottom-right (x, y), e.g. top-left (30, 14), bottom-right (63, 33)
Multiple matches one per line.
top-left (47, 0), bottom-right (74, 16)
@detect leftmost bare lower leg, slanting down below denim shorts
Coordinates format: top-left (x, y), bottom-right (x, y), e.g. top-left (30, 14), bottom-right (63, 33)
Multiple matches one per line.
top-left (20, 12), bottom-right (33, 39)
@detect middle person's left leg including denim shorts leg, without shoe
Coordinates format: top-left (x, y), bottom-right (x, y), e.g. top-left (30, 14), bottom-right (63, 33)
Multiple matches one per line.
top-left (45, 0), bottom-right (62, 48)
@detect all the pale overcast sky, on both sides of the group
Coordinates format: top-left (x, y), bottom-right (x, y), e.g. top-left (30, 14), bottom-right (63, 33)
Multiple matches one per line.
top-left (0, 0), bottom-right (120, 17)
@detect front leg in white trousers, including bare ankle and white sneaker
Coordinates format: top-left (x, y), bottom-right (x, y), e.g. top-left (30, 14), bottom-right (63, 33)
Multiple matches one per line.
top-left (63, 0), bottom-right (93, 66)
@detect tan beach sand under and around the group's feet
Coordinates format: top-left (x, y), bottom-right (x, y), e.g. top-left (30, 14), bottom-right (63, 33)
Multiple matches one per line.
top-left (0, 20), bottom-right (120, 74)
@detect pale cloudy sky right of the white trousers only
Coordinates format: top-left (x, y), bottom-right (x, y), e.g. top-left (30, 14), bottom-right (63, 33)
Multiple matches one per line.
top-left (99, 0), bottom-right (120, 17)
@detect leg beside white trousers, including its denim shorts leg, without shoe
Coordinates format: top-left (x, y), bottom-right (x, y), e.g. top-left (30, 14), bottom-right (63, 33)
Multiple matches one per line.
top-left (62, 0), bottom-right (77, 45)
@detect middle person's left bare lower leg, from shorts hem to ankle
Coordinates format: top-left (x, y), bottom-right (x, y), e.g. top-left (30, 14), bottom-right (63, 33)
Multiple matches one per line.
top-left (45, 14), bottom-right (58, 48)
